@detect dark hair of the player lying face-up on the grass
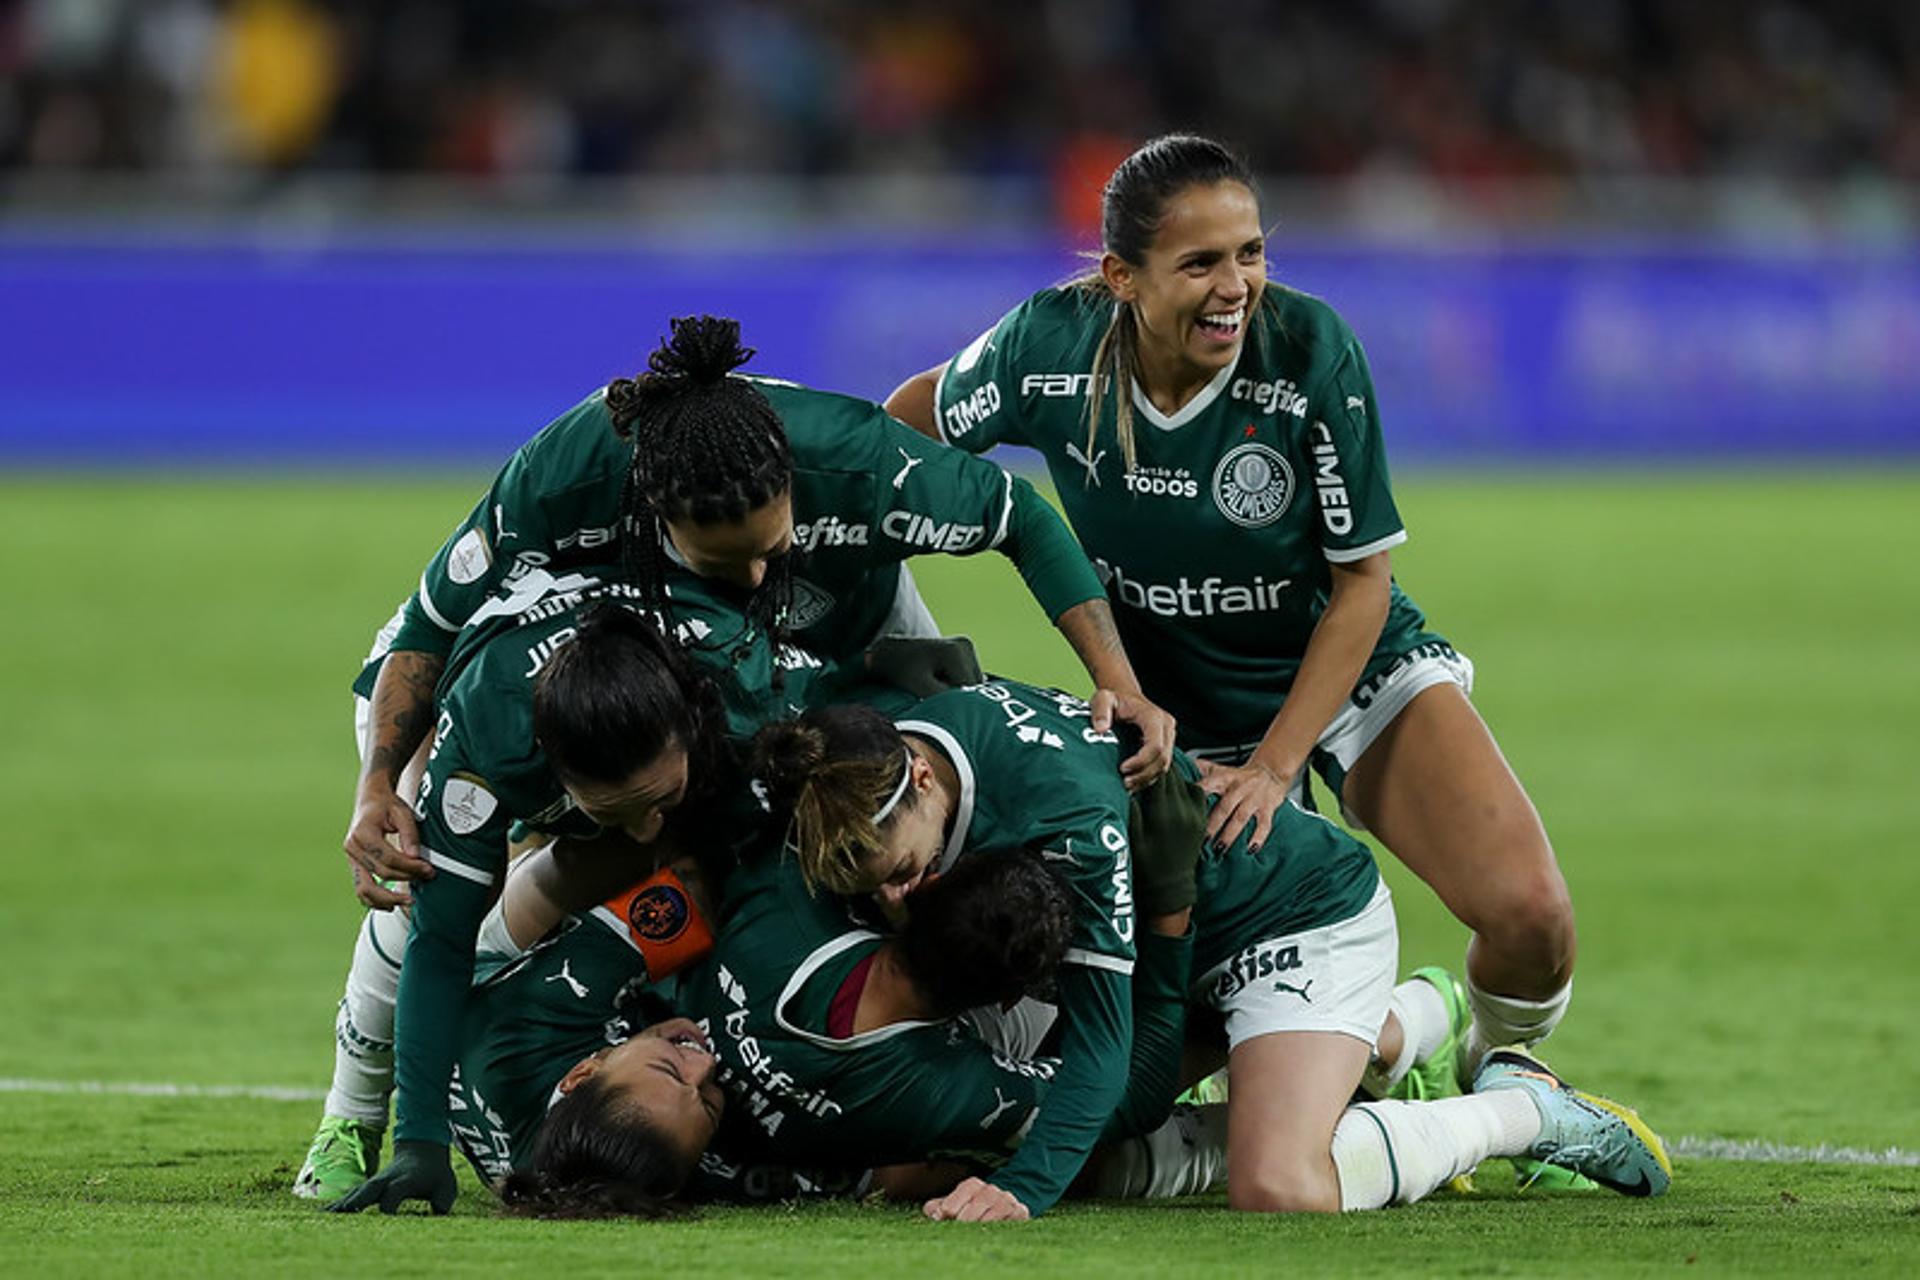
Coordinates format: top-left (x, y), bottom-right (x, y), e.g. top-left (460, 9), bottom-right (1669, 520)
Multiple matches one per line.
top-left (499, 1077), bottom-right (699, 1219)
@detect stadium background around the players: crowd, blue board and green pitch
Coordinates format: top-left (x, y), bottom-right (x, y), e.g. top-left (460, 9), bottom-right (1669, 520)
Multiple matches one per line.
top-left (0, 0), bottom-right (1920, 1274)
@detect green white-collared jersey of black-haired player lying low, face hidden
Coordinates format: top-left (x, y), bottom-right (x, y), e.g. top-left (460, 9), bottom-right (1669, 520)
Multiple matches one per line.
top-left (680, 854), bottom-right (1054, 1167)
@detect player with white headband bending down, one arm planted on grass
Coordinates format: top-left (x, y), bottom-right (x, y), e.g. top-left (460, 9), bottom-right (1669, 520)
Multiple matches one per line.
top-left (756, 679), bottom-right (1198, 1221)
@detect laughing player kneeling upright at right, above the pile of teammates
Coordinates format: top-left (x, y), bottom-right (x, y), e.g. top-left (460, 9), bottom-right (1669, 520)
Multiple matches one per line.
top-left (887, 134), bottom-right (1574, 1067)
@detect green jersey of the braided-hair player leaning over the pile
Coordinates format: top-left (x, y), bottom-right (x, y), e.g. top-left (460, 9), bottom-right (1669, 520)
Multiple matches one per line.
top-left (361, 378), bottom-right (1100, 693)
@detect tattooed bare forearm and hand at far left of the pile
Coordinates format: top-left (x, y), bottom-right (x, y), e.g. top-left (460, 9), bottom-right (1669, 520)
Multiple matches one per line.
top-left (342, 651), bottom-right (445, 912)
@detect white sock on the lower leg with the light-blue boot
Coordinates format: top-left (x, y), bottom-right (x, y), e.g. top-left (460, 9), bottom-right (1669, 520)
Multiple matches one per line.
top-left (1332, 1090), bottom-right (1540, 1209)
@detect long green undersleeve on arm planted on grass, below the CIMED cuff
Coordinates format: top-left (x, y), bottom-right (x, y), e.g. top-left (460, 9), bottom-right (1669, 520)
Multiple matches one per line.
top-left (991, 965), bottom-right (1133, 1217)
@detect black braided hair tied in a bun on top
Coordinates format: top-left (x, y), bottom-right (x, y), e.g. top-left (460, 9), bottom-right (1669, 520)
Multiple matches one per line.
top-left (607, 315), bottom-right (793, 643)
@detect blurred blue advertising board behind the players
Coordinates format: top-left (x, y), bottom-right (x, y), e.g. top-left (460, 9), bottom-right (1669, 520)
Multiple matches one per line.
top-left (0, 228), bottom-right (1920, 466)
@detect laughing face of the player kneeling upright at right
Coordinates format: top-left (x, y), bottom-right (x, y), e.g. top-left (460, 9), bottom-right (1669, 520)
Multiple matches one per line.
top-left (1100, 182), bottom-right (1267, 395)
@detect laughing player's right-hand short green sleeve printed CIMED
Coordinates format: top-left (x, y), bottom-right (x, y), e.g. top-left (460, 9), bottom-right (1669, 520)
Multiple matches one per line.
top-left (1308, 338), bottom-right (1407, 564)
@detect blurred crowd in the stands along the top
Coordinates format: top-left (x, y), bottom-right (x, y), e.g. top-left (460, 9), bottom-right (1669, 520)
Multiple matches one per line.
top-left (0, 0), bottom-right (1920, 200)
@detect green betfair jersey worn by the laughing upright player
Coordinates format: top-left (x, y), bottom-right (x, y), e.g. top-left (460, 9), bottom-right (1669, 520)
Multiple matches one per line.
top-left (935, 286), bottom-right (1438, 750)
